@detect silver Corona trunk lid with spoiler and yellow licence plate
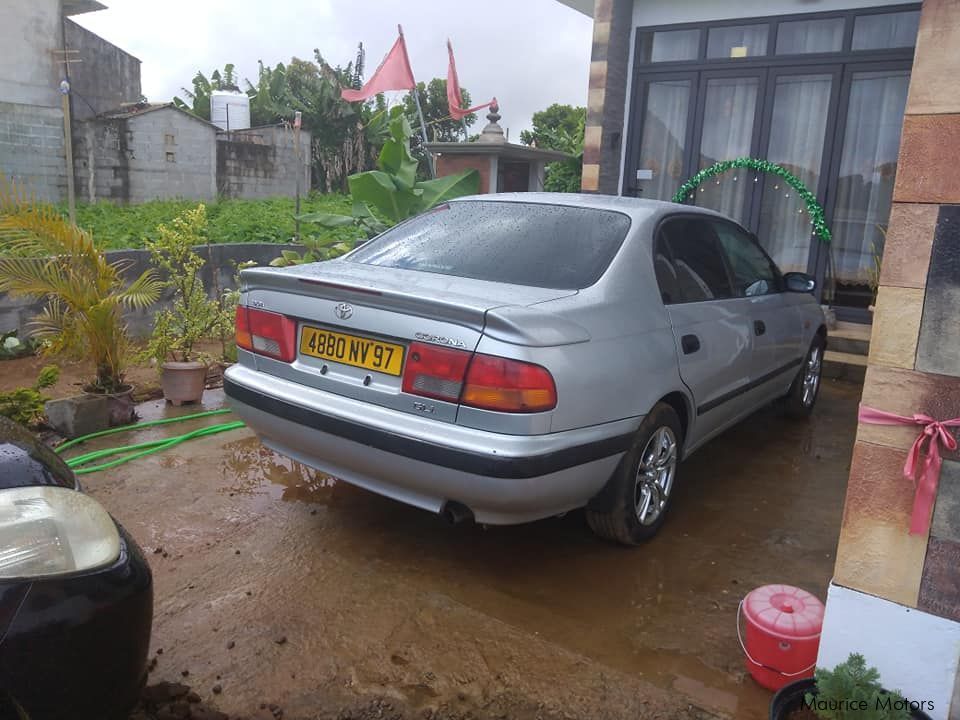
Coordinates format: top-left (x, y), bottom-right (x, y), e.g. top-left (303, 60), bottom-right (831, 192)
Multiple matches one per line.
top-left (241, 259), bottom-right (577, 422)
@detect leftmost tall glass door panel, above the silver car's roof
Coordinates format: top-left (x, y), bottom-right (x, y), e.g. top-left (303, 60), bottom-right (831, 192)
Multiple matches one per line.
top-left (636, 78), bottom-right (693, 200)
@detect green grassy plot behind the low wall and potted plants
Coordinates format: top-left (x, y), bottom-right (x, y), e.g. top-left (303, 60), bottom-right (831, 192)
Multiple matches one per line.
top-left (60, 194), bottom-right (359, 250)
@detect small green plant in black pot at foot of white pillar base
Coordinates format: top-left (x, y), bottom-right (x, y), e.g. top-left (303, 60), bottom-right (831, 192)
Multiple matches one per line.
top-left (770, 653), bottom-right (930, 720)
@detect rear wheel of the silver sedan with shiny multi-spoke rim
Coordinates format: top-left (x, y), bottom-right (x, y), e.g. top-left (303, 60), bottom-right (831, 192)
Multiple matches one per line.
top-left (586, 403), bottom-right (683, 545)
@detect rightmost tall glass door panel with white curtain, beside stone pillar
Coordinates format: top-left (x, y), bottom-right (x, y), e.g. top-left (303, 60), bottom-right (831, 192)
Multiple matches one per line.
top-left (830, 67), bottom-right (910, 308)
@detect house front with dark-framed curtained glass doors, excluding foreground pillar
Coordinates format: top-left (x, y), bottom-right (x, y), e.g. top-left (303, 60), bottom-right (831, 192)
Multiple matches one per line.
top-left (562, 0), bottom-right (920, 322)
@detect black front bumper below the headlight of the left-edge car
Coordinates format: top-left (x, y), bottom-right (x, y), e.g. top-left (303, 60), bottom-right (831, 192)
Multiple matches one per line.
top-left (0, 526), bottom-right (153, 720)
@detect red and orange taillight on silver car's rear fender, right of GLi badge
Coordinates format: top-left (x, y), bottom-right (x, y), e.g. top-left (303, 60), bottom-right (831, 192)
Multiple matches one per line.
top-left (460, 355), bottom-right (557, 412)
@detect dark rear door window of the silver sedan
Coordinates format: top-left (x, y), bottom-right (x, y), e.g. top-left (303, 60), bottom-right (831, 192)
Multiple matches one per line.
top-left (654, 218), bottom-right (734, 305)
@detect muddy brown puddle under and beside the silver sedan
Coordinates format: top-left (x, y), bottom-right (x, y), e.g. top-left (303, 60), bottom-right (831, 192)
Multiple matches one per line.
top-left (222, 384), bottom-right (859, 720)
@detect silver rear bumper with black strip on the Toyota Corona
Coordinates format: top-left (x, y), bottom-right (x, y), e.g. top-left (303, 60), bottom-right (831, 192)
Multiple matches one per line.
top-left (224, 365), bottom-right (642, 524)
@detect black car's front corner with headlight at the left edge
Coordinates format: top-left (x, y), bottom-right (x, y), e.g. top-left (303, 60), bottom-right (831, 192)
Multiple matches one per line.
top-left (0, 417), bottom-right (153, 720)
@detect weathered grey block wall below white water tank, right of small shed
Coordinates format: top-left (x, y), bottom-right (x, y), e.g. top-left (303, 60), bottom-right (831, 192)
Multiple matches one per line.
top-left (216, 126), bottom-right (311, 199)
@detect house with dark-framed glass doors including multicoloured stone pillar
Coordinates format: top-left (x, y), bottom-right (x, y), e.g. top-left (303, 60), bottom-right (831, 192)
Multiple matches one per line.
top-left (560, 0), bottom-right (960, 720)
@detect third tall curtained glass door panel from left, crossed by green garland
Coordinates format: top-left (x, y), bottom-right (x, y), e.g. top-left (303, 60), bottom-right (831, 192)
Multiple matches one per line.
top-left (757, 68), bottom-right (839, 272)
